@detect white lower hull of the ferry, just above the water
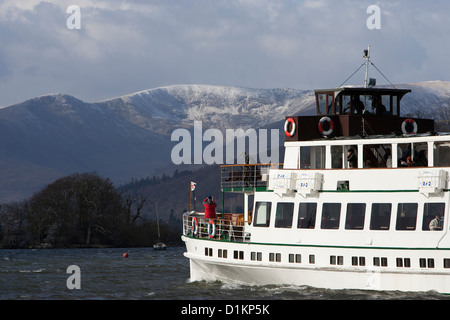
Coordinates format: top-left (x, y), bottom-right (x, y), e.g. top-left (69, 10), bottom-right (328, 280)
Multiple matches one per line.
top-left (183, 237), bottom-right (450, 293)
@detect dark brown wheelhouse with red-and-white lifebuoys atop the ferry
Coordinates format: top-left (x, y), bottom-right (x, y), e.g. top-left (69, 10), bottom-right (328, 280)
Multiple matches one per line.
top-left (285, 87), bottom-right (434, 141)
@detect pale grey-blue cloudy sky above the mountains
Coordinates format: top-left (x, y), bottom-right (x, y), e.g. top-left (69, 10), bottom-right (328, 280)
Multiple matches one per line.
top-left (0, 0), bottom-right (450, 106)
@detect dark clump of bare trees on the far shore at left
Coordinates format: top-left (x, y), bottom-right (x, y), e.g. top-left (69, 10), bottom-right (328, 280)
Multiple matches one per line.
top-left (0, 173), bottom-right (180, 248)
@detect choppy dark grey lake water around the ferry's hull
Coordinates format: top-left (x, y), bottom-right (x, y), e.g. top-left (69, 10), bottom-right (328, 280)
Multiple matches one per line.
top-left (0, 247), bottom-right (450, 301)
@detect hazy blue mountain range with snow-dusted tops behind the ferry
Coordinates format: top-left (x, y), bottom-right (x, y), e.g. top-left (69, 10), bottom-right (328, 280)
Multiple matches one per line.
top-left (0, 81), bottom-right (450, 201)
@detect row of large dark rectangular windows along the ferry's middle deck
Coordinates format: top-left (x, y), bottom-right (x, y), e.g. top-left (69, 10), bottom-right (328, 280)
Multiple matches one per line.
top-left (253, 201), bottom-right (445, 231)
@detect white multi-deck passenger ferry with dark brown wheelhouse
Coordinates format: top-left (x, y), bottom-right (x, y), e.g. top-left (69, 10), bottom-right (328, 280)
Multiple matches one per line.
top-left (182, 53), bottom-right (450, 293)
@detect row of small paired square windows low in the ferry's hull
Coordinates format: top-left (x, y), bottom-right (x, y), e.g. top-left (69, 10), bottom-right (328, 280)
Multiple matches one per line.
top-left (209, 247), bottom-right (450, 269)
